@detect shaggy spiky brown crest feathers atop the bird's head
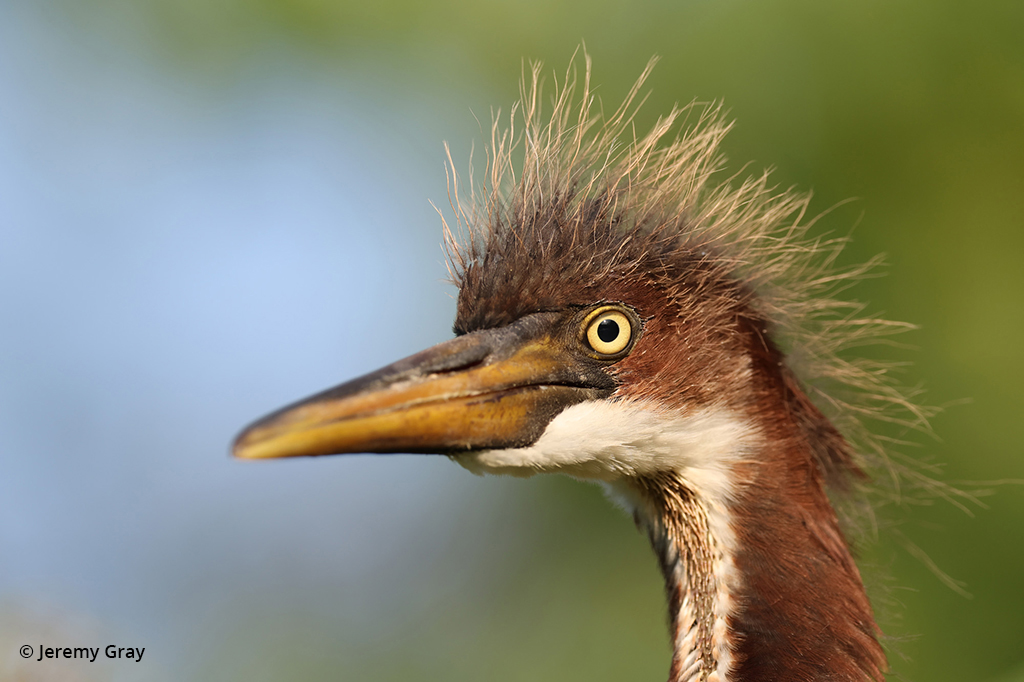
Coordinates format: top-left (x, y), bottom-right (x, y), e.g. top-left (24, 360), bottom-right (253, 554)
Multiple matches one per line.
top-left (444, 57), bottom-right (942, 509)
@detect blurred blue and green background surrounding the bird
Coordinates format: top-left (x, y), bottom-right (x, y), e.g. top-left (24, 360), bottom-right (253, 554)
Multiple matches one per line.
top-left (0, 0), bottom-right (1024, 682)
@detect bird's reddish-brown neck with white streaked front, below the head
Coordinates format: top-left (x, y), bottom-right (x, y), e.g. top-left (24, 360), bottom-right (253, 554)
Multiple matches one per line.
top-left (631, 430), bottom-right (886, 682)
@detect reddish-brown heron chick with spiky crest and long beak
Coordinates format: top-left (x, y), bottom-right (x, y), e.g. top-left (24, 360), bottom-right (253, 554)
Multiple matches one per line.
top-left (233, 55), bottom-right (924, 682)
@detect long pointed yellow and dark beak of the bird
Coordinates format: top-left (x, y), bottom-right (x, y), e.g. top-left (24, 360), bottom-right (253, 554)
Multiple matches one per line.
top-left (233, 313), bottom-right (614, 459)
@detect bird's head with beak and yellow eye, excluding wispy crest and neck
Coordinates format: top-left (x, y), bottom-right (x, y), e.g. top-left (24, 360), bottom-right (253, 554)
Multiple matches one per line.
top-left (236, 222), bottom-right (766, 481)
